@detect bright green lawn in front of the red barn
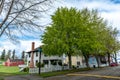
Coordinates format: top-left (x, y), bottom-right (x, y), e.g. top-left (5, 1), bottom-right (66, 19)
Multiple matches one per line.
top-left (0, 65), bottom-right (27, 77)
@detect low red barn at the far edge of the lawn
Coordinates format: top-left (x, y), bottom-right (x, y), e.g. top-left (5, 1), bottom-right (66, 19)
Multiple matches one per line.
top-left (4, 59), bottom-right (24, 66)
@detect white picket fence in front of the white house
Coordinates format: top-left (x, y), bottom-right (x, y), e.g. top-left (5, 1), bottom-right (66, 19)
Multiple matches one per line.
top-left (29, 66), bottom-right (69, 73)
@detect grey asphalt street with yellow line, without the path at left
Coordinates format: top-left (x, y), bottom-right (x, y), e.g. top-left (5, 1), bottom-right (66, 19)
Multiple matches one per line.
top-left (43, 66), bottom-right (120, 80)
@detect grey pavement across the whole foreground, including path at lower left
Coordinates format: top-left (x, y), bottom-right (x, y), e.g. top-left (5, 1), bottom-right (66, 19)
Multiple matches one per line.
top-left (5, 66), bottom-right (120, 80)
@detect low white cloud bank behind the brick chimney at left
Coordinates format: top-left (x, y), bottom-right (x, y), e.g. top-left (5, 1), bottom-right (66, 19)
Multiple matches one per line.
top-left (0, 40), bottom-right (43, 56)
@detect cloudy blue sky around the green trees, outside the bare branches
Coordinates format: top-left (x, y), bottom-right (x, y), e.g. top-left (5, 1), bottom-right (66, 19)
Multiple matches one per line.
top-left (0, 0), bottom-right (120, 57)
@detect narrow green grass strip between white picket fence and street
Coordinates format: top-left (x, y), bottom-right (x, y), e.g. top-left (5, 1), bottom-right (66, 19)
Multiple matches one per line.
top-left (40, 68), bottom-right (91, 78)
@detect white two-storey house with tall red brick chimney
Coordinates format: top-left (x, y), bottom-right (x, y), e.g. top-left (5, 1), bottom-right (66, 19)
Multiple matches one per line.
top-left (26, 42), bottom-right (63, 67)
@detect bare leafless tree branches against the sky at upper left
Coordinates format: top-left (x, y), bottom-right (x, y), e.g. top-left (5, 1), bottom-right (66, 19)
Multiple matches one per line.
top-left (0, 0), bottom-right (53, 39)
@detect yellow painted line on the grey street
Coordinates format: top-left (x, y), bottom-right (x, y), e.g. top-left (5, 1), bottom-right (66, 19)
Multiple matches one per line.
top-left (67, 74), bottom-right (120, 79)
